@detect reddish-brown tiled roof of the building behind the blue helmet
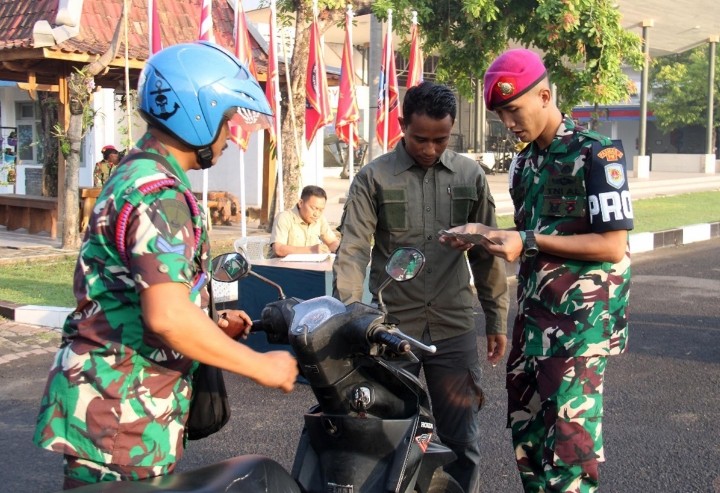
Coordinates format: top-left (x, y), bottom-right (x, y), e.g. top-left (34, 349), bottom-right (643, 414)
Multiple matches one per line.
top-left (0, 0), bottom-right (267, 88)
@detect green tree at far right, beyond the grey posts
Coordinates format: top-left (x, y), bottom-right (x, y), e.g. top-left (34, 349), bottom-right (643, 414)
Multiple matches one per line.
top-left (649, 48), bottom-right (720, 132)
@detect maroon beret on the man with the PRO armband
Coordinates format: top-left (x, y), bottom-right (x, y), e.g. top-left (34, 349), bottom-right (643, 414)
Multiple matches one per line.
top-left (484, 48), bottom-right (547, 110)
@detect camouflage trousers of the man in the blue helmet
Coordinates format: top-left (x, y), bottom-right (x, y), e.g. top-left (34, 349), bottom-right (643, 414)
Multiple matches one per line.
top-left (63, 455), bottom-right (175, 490)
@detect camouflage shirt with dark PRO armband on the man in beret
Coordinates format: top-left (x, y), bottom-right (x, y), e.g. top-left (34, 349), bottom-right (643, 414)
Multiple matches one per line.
top-left (510, 118), bottom-right (633, 357)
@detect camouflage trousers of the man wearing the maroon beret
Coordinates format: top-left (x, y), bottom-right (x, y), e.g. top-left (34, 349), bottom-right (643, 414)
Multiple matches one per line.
top-left (506, 345), bottom-right (607, 493)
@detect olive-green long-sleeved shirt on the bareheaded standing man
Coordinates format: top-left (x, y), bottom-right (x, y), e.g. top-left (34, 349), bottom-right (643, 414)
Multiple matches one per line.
top-left (333, 138), bottom-right (507, 341)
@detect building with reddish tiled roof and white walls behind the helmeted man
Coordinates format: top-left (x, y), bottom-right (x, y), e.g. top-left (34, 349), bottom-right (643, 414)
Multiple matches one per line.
top-left (0, 0), bottom-right (267, 217)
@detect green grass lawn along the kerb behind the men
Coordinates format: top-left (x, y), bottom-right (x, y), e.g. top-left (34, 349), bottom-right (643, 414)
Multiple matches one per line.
top-left (0, 192), bottom-right (720, 306)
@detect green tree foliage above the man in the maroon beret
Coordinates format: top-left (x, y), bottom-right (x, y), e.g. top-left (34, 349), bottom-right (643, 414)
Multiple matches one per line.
top-left (372, 0), bottom-right (643, 110)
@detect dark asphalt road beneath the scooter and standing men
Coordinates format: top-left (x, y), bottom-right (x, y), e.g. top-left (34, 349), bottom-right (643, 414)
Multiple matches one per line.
top-left (0, 239), bottom-right (720, 493)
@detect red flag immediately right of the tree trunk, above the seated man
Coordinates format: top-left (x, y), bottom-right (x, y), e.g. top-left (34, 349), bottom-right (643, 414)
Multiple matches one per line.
top-left (305, 18), bottom-right (332, 146)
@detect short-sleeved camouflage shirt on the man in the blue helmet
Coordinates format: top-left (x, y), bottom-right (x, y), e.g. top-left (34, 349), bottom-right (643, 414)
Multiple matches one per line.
top-left (34, 134), bottom-right (209, 467)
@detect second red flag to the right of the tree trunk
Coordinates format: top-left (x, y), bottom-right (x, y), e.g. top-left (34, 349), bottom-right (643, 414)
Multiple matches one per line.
top-left (335, 14), bottom-right (360, 148)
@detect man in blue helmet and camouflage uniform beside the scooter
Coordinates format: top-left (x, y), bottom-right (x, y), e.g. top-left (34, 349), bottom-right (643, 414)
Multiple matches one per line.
top-left (34, 42), bottom-right (297, 489)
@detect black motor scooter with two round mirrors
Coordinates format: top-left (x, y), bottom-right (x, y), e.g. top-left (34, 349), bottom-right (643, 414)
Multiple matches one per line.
top-left (66, 247), bottom-right (463, 493)
